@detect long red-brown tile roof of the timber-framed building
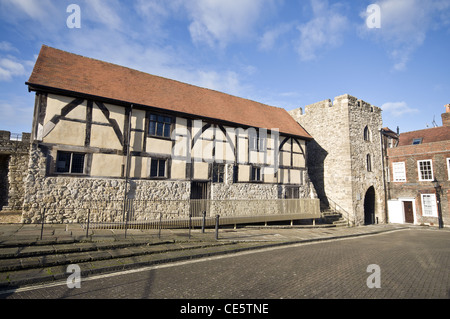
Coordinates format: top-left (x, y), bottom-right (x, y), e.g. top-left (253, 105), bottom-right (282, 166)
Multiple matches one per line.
top-left (26, 45), bottom-right (311, 139)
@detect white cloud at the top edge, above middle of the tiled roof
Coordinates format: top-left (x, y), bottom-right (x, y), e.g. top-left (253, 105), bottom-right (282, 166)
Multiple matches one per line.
top-left (185, 0), bottom-right (273, 48)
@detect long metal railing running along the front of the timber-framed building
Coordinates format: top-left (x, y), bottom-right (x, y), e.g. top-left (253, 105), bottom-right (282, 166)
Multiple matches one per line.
top-left (35, 199), bottom-right (321, 240)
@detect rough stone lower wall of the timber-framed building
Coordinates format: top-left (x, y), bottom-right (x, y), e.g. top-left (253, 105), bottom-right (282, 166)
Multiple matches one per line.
top-left (22, 144), bottom-right (315, 223)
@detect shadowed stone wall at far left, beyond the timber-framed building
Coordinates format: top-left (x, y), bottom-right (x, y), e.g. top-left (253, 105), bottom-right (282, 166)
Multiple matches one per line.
top-left (0, 131), bottom-right (30, 212)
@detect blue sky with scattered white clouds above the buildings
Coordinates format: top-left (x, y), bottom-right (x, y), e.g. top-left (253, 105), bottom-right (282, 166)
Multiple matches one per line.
top-left (0, 0), bottom-right (450, 133)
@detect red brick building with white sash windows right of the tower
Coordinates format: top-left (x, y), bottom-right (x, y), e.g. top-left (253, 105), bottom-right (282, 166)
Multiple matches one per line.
top-left (387, 105), bottom-right (450, 226)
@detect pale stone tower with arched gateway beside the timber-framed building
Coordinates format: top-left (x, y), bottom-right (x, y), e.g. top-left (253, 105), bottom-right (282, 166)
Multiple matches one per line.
top-left (289, 94), bottom-right (386, 225)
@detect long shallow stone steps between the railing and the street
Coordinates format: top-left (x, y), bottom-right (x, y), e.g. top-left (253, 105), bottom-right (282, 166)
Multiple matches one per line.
top-left (0, 225), bottom-right (436, 290)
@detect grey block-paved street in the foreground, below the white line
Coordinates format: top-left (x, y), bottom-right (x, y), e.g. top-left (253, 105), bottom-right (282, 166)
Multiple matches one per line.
top-left (0, 229), bottom-right (450, 300)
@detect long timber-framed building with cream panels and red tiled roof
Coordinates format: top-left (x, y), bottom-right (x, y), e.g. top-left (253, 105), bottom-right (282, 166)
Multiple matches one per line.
top-left (19, 46), bottom-right (318, 222)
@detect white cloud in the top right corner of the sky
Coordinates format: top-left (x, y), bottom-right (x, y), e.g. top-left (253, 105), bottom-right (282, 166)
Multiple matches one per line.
top-left (360, 0), bottom-right (450, 71)
